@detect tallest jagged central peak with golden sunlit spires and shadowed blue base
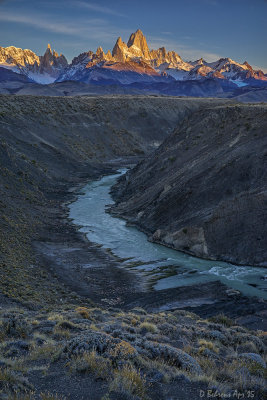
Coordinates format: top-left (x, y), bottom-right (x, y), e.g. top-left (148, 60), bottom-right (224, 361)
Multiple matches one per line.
top-left (57, 30), bottom-right (173, 85)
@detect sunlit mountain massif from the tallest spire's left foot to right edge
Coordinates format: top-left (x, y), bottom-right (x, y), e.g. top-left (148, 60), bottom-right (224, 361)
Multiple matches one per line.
top-left (58, 29), bottom-right (267, 86)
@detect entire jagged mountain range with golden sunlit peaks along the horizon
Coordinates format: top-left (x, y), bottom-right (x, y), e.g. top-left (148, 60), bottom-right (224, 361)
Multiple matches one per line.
top-left (0, 29), bottom-right (267, 96)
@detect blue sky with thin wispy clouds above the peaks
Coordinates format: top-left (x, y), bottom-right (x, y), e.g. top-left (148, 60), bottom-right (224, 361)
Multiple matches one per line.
top-left (0, 0), bottom-right (267, 73)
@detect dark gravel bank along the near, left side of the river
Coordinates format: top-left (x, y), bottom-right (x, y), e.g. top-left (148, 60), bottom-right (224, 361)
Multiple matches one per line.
top-left (31, 159), bottom-right (266, 329)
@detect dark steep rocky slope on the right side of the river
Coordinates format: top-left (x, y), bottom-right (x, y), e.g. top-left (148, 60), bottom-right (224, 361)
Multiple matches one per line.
top-left (113, 105), bottom-right (267, 265)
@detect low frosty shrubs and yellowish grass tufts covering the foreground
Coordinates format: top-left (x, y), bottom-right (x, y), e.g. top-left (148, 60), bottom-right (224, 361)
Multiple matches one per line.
top-left (0, 306), bottom-right (266, 400)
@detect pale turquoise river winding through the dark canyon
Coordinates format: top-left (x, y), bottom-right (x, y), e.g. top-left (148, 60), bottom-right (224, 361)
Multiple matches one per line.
top-left (69, 169), bottom-right (267, 299)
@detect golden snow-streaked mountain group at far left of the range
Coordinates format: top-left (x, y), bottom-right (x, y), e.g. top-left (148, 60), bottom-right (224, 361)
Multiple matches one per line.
top-left (0, 44), bottom-right (68, 84)
